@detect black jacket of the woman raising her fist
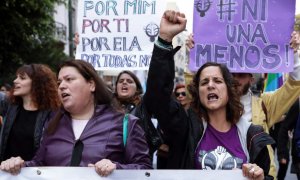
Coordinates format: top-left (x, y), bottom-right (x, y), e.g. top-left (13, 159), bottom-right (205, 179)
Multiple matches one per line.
top-left (144, 45), bottom-right (274, 179)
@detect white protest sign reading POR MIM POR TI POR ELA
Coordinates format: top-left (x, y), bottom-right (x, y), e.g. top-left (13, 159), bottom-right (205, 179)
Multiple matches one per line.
top-left (76, 0), bottom-right (166, 70)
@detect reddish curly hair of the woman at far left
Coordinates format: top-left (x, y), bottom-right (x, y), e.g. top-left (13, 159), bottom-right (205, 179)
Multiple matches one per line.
top-left (10, 64), bottom-right (60, 110)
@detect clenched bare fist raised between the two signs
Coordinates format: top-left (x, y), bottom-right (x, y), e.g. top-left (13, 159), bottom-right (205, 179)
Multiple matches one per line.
top-left (159, 10), bottom-right (187, 42)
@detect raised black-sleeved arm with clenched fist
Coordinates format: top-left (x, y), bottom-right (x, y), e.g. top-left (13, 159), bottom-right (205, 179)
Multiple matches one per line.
top-left (144, 11), bottom-right (186, 135)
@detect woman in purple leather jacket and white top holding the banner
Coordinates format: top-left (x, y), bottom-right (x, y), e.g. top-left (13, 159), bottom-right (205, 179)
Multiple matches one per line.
top-left (1, 60), bottom-right (151, 176)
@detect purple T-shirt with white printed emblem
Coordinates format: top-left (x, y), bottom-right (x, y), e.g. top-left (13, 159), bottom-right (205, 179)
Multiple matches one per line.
top-left (195, 124), bottom-right (247, 170)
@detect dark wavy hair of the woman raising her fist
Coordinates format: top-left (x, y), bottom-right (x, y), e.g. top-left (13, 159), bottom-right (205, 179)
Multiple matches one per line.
top-left (188, 62), bottom-right (244, 124)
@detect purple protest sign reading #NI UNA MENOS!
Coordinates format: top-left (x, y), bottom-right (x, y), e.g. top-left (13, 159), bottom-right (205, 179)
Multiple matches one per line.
top-left (189, 0), bottom-right (295, 73)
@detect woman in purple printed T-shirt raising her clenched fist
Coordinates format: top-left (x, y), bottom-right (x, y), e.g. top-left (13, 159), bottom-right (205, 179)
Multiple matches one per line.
top-left (144, 11), bottom-right (274, 180)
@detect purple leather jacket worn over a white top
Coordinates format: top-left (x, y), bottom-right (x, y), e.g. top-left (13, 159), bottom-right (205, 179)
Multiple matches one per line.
top-left (26, 105), bottom-right (152, 169)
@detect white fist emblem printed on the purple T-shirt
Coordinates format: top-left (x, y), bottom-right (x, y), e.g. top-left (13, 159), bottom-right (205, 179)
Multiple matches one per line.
top-left (198, 146), bottom-right (243, 170)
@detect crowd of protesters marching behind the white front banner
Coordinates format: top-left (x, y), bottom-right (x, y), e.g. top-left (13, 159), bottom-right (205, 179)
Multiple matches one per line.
top-left (0, 10), bottom-right (300, 180)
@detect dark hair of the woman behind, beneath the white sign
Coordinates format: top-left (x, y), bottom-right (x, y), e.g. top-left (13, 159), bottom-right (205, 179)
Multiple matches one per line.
top-left (114, 70), bottom-right (143, 104)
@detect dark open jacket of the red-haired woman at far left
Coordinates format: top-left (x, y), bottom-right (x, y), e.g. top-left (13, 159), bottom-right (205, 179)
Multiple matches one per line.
top-left (0, 103), bottom-right (51, 162)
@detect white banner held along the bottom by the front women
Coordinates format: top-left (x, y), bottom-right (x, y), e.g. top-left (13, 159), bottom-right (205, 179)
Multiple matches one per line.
top-left (0, 167), bottom-right (247, 180)
